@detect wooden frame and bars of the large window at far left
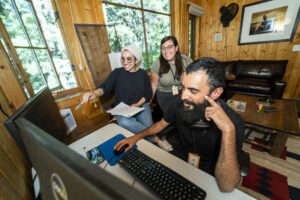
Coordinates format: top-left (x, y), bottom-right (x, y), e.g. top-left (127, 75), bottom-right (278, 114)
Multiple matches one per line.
top-left (0, 0), bottom-right (82, 97)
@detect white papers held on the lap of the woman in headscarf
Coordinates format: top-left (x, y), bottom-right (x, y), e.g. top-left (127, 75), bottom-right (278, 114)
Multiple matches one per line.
top-left (106, 102), bottom-right (144, 117)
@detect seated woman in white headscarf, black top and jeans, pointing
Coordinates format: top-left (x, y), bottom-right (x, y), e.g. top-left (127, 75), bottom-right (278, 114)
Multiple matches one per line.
top-left (83, 46), bottom-right (166, 147)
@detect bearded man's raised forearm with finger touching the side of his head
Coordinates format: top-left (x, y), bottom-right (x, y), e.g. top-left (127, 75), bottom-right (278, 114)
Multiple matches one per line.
top-left (205, 97), bottom-right (241, 192)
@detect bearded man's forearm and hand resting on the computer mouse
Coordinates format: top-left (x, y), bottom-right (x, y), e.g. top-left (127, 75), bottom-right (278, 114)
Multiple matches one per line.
top-left (114, 118), bottom-right (169, 152)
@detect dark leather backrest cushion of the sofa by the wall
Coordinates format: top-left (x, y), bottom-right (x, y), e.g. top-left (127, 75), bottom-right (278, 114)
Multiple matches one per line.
top-left (234, 60), bottom-right (288, 79)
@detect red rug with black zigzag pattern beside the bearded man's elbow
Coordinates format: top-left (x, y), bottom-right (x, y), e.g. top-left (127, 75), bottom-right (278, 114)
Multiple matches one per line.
top-left (242, 163), bottom-right (290, 200)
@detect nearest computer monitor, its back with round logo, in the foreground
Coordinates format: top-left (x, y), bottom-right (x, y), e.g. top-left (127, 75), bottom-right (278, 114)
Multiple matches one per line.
top-left (16, 118), bottom-right (150, 200)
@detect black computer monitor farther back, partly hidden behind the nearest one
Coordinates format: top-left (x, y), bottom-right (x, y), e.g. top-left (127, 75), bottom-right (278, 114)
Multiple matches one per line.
top-left (4, 87), bottom-right (67, 159)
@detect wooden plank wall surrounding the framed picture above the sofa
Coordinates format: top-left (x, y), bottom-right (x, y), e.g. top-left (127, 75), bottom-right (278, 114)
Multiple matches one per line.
top-left (196, 0), bottom-right (300, 99)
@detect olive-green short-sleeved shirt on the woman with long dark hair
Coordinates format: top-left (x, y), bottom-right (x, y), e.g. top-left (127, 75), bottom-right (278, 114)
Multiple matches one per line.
top-left (151, 54), bottom-right (193, 92)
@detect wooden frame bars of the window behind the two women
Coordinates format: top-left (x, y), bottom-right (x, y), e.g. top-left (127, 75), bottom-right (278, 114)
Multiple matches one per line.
top-left (102, 0), bottom-right (174, 69)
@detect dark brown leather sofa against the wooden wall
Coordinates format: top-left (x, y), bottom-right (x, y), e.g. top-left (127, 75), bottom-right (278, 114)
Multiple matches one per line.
top-left (222, 60), bottom-right (288, 99)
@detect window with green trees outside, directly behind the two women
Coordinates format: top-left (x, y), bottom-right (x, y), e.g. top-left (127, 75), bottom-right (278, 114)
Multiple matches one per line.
top-left (102, 0), bottom-right (171, 69)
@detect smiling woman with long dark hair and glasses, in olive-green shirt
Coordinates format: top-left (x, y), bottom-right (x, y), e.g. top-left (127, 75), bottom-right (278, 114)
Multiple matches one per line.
top-left (151, 36), bottom-right (193, 113)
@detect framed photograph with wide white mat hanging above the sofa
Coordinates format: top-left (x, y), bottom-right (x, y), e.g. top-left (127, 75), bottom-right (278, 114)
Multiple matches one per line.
top-left (239, 0), bottom-right (300, 45)
